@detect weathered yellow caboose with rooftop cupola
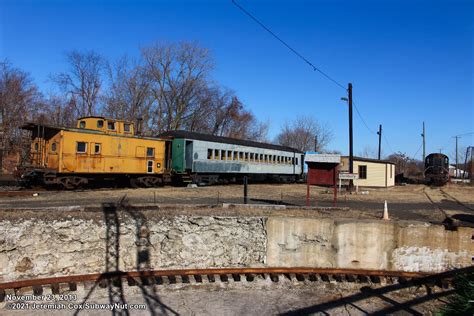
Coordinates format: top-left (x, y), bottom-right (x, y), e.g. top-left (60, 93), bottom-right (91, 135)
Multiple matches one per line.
top-left (22, 116), bottom-right (171, 189)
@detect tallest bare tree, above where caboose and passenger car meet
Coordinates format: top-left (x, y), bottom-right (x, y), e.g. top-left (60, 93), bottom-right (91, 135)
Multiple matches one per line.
top-left (142, 43), bottom-right (213, 131)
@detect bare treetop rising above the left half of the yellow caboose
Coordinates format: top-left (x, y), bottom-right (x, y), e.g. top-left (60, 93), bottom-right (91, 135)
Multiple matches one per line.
top-left (53, 50), bottom-right (104, 116)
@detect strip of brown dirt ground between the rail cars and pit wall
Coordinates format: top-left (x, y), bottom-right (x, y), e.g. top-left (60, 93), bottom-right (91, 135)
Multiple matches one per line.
top-left (0, 184), bottom-right (474, 225)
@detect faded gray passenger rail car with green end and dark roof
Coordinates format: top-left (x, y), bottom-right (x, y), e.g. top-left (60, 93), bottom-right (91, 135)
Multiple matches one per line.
top-left (158, 131), bottom-right (304, 184)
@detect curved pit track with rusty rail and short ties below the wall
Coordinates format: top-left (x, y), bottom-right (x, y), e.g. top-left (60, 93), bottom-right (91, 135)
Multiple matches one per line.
top-left (0, 267), bottom-right (458, 302)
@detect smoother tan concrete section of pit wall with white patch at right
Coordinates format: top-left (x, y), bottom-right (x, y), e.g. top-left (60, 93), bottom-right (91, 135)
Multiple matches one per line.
top-left (266, 217), bottom-right (474, 272)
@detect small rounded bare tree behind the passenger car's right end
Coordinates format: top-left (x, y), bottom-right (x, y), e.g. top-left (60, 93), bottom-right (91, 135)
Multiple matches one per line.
top-left (276, 116), bottom-right (332, 151)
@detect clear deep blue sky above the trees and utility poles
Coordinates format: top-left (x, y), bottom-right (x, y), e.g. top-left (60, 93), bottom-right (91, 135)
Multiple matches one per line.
top-left (0, 0), bottom-right (474, 158)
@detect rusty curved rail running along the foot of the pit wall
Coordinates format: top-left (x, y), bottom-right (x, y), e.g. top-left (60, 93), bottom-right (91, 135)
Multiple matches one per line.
top-left (0, 268), bottom-right (444, 302)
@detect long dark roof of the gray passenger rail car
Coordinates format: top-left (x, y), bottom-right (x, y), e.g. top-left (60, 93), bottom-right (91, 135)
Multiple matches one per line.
top-left (158, 130), bottom-right (303, 153)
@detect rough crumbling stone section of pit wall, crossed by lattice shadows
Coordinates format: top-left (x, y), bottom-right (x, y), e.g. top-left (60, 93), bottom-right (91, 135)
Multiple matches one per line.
top-left (0, 216), bottom-right (266, 282)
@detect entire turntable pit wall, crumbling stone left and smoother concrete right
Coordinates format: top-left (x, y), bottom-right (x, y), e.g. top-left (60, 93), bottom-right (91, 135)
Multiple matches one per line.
top-left (0, 212), bottom-right (474, 282)
